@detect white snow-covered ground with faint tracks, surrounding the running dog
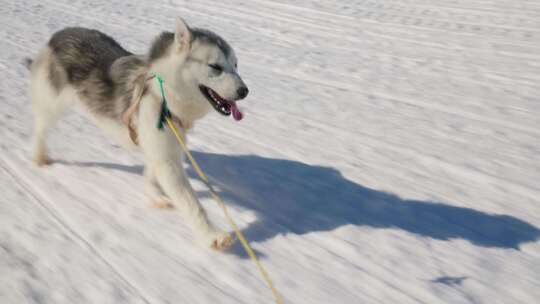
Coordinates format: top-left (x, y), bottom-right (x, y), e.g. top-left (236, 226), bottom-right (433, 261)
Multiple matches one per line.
top-left (0, 0), bottom-right (540, 304)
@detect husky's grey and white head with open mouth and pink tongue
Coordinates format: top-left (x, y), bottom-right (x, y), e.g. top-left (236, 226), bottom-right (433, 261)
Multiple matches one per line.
top-left (150, 18), bottom-right (249, 120)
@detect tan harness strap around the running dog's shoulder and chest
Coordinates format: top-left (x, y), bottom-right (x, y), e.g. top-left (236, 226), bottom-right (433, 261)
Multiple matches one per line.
top-left (122, 73), bottom-right (184, 146)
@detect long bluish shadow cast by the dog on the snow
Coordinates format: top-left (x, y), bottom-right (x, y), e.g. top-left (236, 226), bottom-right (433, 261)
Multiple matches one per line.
top-left (62, 152), bottom-right (540, 255)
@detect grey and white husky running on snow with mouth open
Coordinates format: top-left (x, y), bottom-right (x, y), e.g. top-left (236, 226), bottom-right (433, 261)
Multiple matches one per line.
top-left (28, 18), bottom-right (248, 249)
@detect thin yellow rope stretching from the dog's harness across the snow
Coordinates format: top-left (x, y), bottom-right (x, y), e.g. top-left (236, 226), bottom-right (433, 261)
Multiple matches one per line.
top-left (166, 117), bottom-right (283, 304)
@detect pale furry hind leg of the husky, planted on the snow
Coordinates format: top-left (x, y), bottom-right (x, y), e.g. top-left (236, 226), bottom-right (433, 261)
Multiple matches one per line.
top-left (30, 49), bottom-right (74, 166)
